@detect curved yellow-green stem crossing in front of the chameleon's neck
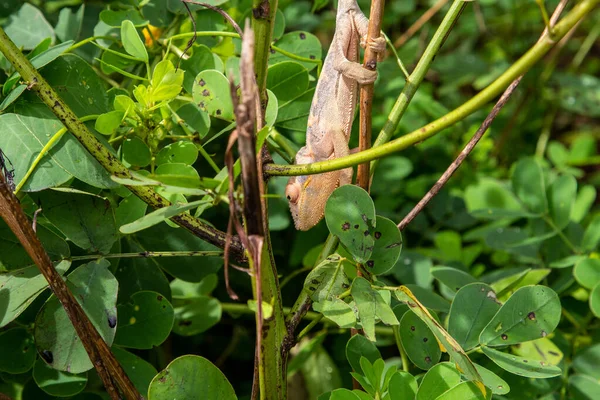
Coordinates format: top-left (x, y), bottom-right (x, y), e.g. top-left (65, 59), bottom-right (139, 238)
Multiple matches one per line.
top-left (265, 0), bottom-right (600, 176)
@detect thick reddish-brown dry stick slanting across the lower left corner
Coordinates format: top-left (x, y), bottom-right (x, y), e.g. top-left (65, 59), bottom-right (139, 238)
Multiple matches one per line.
top-left (0, 173), bottom-right (143, 400)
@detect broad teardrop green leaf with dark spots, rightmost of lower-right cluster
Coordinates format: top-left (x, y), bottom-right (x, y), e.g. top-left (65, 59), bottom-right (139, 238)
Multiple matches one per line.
top-left (479, 286), bottom-right (561, 346)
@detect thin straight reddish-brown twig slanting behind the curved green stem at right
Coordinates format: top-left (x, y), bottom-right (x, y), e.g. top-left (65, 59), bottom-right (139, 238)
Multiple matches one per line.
top-left (398, 0), bottom-right (568, 231)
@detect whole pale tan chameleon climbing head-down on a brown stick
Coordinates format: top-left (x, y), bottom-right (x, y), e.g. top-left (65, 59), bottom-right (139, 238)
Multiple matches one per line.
top-left (285, 0), bottom-right (386, 231)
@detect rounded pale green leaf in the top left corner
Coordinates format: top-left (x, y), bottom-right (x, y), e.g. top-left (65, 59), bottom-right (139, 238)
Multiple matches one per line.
top-left (4, 3), bottom-right (56, 50)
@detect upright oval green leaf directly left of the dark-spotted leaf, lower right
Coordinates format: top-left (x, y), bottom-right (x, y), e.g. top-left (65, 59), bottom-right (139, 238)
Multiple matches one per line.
top-left (448, 283), bottom-right (501, 351)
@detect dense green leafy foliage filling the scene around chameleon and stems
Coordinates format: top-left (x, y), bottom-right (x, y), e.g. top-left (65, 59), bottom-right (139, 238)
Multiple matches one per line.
top-left (0, 0), bottom-right (600, 400)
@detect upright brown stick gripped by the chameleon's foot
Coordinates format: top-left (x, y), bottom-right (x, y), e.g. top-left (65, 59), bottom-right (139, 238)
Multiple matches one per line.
top-left (356, 0), bottom-right (385, 191)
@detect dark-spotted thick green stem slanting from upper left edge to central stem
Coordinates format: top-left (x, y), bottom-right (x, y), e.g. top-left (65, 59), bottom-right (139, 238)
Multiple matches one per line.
top-left (0, 28), bottom-right (244, 259)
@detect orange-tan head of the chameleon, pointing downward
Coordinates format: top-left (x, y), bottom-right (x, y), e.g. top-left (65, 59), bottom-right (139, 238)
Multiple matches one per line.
top-left (285, 171), bottom-right (339, 231)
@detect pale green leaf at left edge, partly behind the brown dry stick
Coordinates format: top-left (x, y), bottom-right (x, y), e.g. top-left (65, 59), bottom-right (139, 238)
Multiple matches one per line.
top-left (0, 260), bottom-right (71, 328)
